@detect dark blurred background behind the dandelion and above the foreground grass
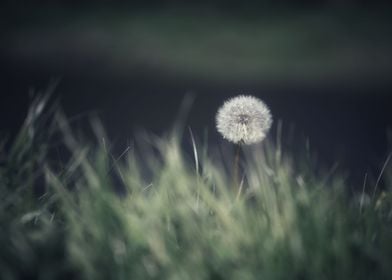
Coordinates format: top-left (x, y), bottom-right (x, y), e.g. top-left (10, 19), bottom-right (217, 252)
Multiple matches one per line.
top-left (0, 0), bottom-right (392, 186)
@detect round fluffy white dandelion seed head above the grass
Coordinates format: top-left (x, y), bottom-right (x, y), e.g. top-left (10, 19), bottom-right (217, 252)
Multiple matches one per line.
top-left (216, 95), bottom-right (272, 144)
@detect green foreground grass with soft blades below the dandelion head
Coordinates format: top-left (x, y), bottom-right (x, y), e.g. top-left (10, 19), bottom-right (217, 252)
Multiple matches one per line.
top-left (0, 92), bottom-right (392, 280)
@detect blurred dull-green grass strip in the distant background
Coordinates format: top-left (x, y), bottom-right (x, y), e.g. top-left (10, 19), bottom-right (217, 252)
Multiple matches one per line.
top-left (2, 9), bottom-right (392, 84)
